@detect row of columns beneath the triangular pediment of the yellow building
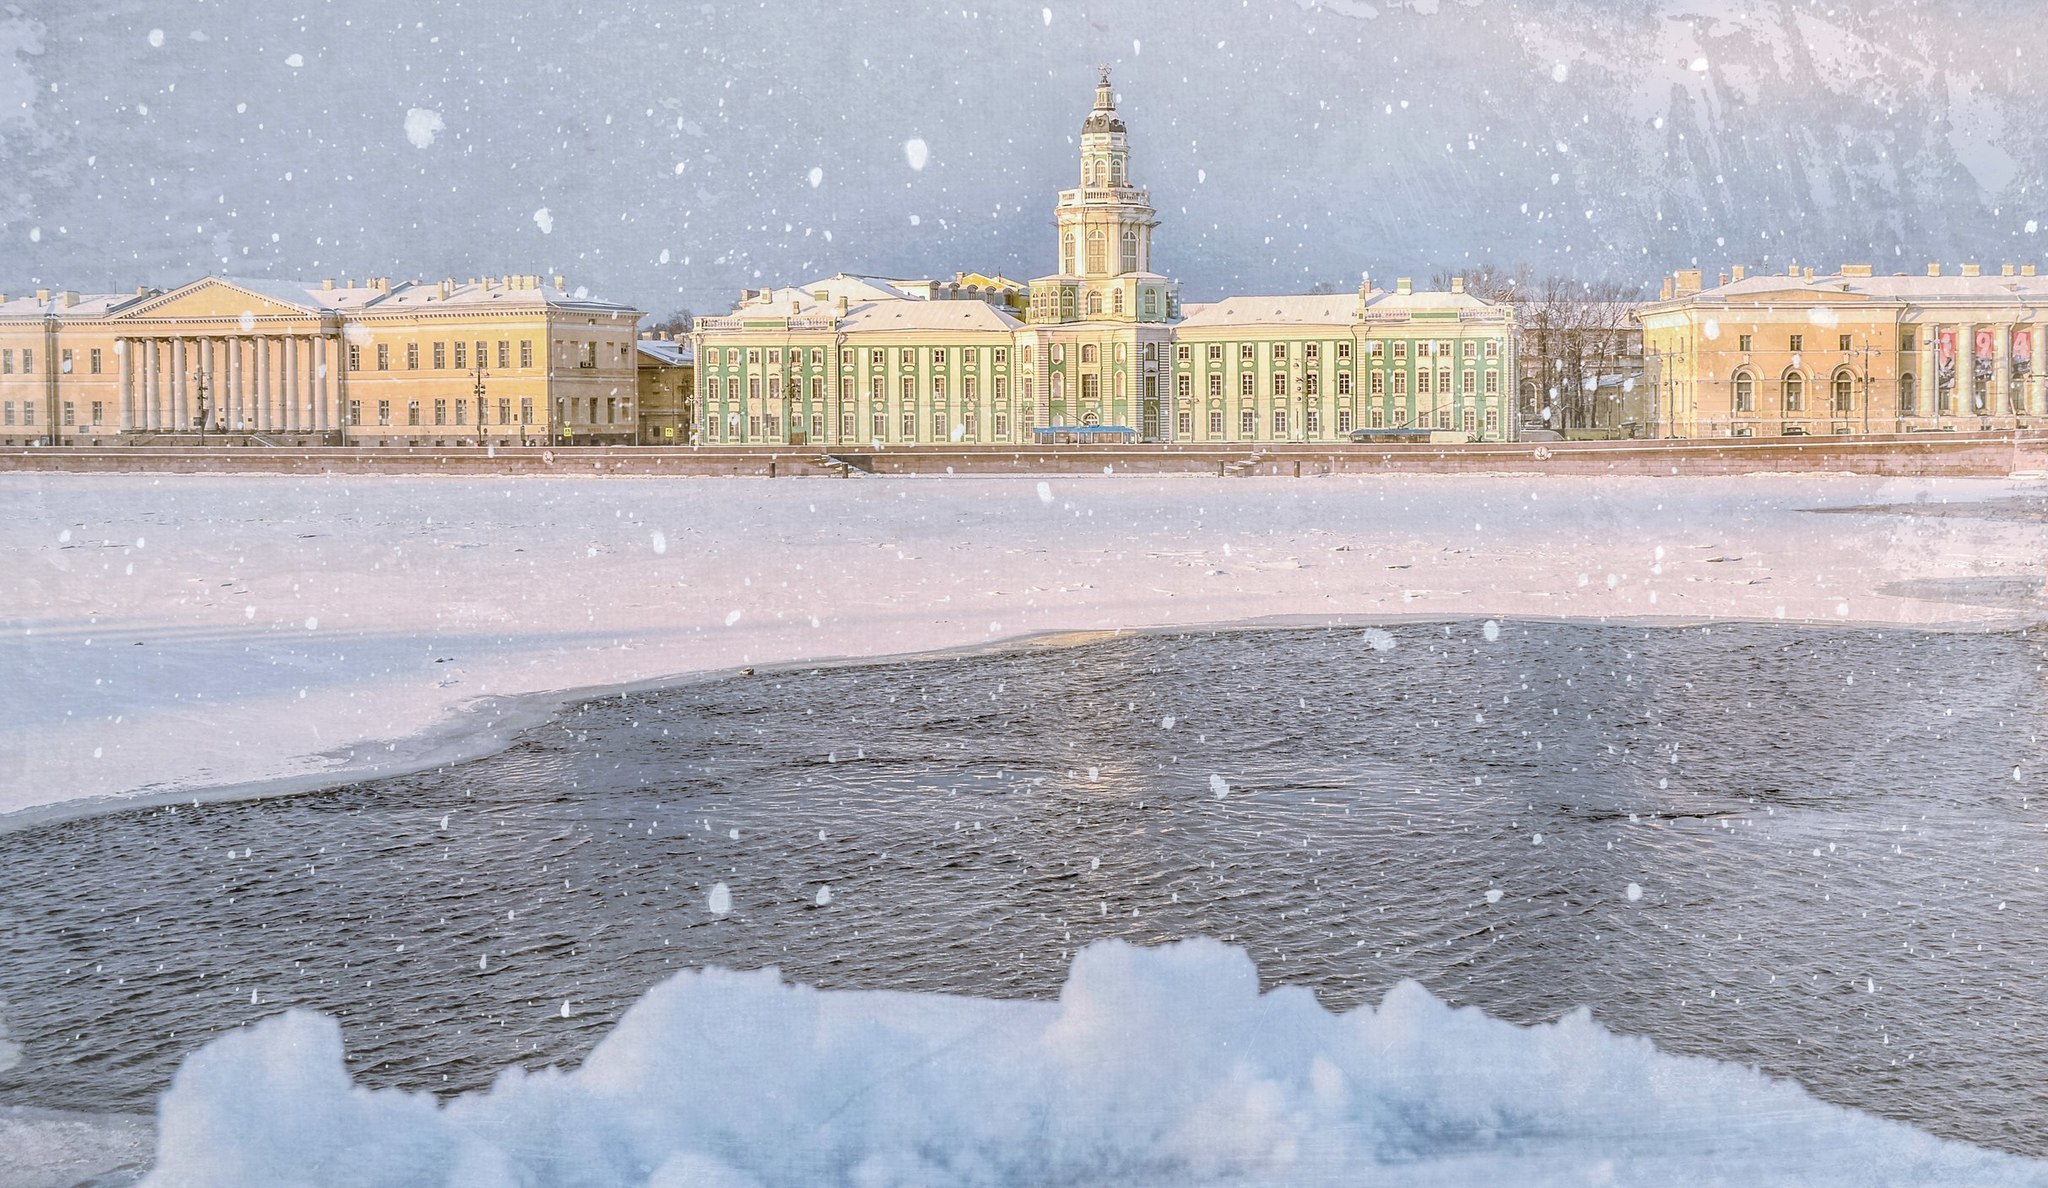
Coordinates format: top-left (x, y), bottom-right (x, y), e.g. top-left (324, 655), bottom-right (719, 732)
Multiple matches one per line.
top-left (115, 330), bottom-right (342, 432)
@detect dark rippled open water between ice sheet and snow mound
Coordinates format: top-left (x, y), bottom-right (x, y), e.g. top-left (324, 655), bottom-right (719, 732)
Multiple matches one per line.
top-left (0, 623), bottom-right (2048, 1155)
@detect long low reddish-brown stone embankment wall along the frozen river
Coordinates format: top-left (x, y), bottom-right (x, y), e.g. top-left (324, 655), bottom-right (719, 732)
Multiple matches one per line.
top-left (0, 430), bottom-right (2048, 477)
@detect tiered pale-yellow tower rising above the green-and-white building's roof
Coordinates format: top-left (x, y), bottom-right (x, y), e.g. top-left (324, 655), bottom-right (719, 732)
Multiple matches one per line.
top-left (1030, 66), bottom-right (1180, 324)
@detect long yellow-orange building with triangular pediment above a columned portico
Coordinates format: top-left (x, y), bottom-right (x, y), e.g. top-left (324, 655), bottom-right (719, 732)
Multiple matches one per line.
top-left (0, 274), bottom-right (641, 444)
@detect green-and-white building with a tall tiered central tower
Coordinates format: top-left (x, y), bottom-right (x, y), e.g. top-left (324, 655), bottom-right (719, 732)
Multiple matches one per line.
top-left (694, 72), bottom-right (1516, 447)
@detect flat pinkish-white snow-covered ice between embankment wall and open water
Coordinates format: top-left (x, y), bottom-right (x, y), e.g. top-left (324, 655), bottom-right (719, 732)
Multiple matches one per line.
top-left (0, 475), bottom-right (2048, 828)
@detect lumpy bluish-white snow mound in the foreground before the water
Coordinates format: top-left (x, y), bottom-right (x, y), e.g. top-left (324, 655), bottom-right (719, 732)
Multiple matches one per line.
top-left (145, 940), bottom-right (2048, 1188)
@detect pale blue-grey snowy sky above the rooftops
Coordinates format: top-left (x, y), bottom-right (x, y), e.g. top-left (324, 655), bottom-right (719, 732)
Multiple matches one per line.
top-left (0, 0), bottom-right (2048, 315)
